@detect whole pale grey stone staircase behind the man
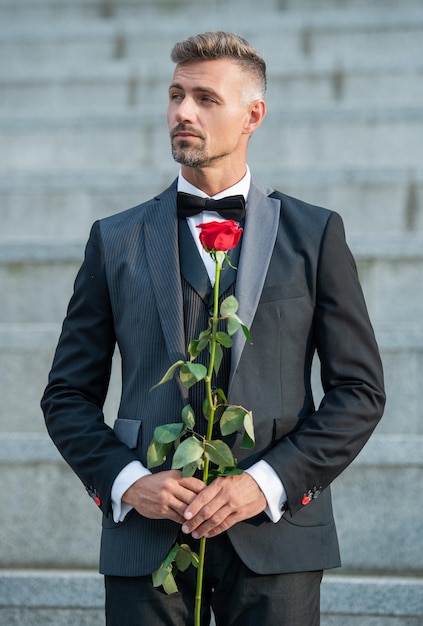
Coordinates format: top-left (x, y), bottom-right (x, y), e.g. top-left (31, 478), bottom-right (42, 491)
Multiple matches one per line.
top-left (0, 0), bottom-right (423, 626)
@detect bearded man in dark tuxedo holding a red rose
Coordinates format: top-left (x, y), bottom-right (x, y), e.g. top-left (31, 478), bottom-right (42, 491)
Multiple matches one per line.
top-left (42, 32), bottom-right (384, 626)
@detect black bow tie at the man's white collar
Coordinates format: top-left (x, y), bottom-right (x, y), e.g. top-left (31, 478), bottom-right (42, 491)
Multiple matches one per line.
top-left (177, 191), bottom-right (245, 222)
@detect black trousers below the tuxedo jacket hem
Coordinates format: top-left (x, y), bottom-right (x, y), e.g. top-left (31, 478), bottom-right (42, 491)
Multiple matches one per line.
top-left (105, 534), bottom-right (322, 626)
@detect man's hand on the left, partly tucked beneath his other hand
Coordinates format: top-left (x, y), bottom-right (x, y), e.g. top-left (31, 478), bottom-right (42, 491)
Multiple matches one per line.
top-left (122, 470), bottom-right (206, 524)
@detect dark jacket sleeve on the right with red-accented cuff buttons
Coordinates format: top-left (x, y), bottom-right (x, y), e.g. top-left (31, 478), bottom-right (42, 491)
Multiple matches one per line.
top-left (264, 213), bottom-right (385, 515)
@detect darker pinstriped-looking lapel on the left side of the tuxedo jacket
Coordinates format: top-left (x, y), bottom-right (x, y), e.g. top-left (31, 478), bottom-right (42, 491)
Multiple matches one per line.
top-left (145, 183), bottom-right (187, 397)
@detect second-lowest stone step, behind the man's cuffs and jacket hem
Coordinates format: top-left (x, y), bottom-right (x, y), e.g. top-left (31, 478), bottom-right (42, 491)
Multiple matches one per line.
top-left (0, 433), bottom-right (423, 576)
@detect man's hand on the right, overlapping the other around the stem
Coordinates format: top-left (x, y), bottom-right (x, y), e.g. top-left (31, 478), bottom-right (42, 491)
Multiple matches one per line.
top-left (182, 473), bottom-right (267, 539)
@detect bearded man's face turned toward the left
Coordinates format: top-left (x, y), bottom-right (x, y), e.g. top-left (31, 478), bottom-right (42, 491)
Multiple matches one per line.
top-left (167, 59), bottom-right (255, 168)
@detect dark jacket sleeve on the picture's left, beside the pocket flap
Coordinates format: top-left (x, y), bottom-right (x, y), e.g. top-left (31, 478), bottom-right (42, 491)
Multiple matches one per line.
top-left (41, 222), bottom-right (137, 514)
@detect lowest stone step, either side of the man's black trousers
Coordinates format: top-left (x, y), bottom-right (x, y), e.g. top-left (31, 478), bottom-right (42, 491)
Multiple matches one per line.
top-left (0, 570), bottom-right (423, 626)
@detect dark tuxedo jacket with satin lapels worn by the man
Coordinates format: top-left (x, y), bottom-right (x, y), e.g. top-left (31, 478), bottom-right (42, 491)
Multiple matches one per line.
top-left (42, 179), bottom-right (384, 576)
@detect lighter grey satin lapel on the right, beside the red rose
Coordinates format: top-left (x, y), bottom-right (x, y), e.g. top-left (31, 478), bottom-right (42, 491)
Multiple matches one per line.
top-left (229, 178), bottom-right (280, 390)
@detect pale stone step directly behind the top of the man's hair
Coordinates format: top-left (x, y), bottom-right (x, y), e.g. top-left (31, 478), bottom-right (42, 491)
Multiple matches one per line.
top-left (0, 10), bottom-right (423, 70)
